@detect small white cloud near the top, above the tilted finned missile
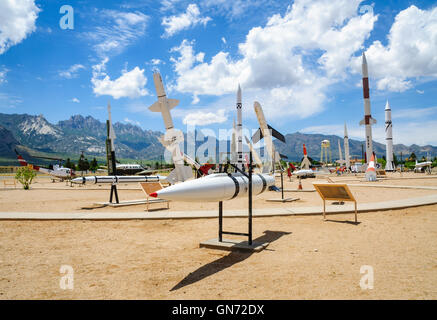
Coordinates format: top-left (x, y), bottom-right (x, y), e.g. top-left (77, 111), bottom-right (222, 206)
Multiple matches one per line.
top-left (162, 3), bottom-right (211, 38)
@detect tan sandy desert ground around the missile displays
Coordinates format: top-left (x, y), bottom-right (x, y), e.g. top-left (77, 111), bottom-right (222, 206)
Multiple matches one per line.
top-left (0, 176), bottom-right (437, 299)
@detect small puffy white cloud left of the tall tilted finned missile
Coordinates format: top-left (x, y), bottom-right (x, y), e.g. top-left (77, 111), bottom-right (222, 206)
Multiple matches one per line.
top-left (91, 58), bottom-right (148, 99)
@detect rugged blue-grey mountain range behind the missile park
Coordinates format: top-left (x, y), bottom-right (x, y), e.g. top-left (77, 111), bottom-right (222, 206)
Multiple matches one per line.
top-left (0, 113), bottom-right (437, 163)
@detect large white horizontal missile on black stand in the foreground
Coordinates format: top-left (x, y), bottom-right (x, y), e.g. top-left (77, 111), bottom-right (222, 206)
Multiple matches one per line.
top-left (150, 173), bottom-right (275, 202)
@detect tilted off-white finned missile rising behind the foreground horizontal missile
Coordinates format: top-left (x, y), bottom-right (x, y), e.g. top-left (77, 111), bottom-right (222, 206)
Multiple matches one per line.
top-left (149, 72), bottom-right (193, 184)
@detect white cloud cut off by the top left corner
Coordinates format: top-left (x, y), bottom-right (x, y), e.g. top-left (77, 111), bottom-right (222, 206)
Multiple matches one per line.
top-left (0, 0), bottom-right (41, 54)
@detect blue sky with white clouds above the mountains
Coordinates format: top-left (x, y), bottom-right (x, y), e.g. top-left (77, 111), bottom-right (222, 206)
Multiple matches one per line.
top-left (0, 0), bottom-right (437, 145)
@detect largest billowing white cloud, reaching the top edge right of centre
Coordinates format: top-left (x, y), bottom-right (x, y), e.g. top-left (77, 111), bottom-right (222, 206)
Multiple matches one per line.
top-left (171, 0), bottom-right (377, 118)
